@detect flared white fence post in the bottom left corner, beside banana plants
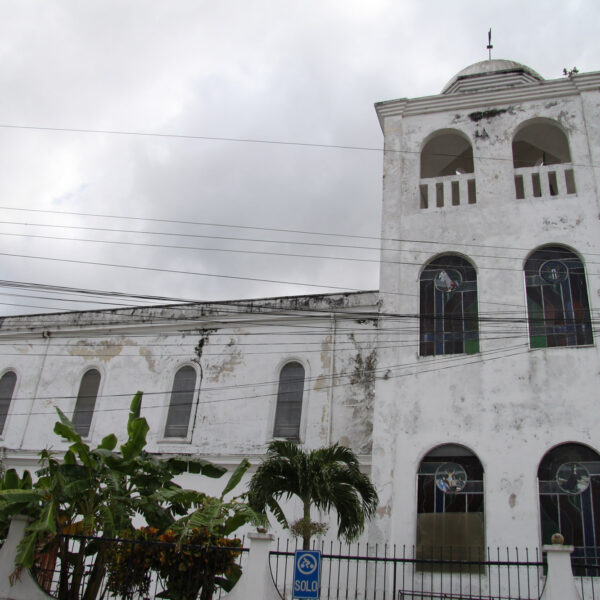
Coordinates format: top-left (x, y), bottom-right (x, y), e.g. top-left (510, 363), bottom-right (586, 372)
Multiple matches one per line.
top-left (0, 515), bottom-right (50, 600)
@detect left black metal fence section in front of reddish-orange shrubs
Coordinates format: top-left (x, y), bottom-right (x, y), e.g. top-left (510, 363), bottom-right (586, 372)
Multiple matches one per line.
top-left (32, 536), bottom-right (248, 600)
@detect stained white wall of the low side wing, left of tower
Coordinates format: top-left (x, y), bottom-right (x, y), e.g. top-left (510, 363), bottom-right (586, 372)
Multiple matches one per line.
top-left (0, 293), bottom-right (377, 474)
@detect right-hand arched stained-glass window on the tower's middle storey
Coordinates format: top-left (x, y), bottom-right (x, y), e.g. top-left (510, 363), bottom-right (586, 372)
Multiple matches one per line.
top-left (525, 246), bottom-right (593, 348)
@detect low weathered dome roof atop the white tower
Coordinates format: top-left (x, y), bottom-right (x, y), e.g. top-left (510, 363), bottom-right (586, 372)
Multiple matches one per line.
top-left (442, 59), bottom-right (544, 94)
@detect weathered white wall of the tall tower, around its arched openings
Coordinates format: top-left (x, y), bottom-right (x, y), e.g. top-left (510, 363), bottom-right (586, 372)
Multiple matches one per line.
top-left (371, 68), bottom-right (600, 547)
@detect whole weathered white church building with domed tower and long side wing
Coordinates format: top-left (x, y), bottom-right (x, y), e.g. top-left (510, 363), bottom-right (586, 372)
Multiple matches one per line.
top-left (0, 60), bottom-right (600, 557)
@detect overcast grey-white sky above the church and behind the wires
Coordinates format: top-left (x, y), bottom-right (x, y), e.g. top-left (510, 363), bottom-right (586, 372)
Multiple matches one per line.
top-left (0, 0), bottom-right (600, 314)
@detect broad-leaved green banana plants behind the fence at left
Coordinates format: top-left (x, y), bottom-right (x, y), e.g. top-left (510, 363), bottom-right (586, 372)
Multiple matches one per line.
top-left (0, 392), bottom-right (261, 600)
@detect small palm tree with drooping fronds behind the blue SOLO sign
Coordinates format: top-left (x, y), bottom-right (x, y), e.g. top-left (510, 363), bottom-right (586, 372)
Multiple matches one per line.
top-left (248, 441), bottom-right (378, 550)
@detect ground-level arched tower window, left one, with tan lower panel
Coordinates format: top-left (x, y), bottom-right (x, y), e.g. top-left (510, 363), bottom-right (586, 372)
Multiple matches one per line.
top-left (417, 444), bottom-right (485, 560)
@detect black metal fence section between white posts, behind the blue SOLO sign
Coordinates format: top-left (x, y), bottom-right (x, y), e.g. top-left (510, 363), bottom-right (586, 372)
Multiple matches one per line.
top-left (270, 541), bottom-right (548, 600)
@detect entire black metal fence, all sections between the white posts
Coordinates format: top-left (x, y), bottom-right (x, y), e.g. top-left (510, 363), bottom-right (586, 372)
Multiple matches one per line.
top-left (27, 536), bottom-right (600, 600)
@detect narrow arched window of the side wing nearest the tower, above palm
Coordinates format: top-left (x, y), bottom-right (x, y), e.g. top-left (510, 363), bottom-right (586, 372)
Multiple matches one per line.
top-left (273, 362), bottom-right (304, 440)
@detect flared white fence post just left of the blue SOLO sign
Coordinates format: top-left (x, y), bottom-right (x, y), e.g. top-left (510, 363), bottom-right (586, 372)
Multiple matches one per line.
top-left (225, 533), bottom-right (281, 600)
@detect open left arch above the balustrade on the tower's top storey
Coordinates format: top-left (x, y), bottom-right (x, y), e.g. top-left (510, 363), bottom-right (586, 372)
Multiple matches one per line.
top-left (421, 132), bottom-right (473, 179)
